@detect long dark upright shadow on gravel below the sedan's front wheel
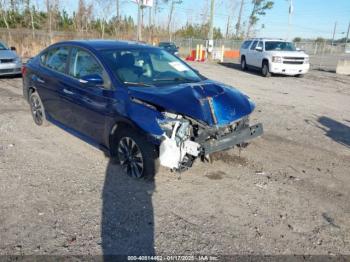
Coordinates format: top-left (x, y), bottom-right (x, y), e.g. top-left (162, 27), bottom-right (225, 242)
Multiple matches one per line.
top-left (101, 162), bottom-right (155, 256)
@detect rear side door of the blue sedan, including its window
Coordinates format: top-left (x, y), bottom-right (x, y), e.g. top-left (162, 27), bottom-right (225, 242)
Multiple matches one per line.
top-left (32, 46), bottom-right (71, 125)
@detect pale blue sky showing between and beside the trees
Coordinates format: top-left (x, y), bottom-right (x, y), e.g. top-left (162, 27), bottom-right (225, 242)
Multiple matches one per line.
top-left (63, 0), bottom-right (350, 39)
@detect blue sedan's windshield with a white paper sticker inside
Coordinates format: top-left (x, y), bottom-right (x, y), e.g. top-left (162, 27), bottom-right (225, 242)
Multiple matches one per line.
top-left (102, 48), bottom-right (202, 86)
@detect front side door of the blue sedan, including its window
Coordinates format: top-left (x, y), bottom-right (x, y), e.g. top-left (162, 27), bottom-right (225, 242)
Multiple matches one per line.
top-left (65, 47), bottom-right (116, 143)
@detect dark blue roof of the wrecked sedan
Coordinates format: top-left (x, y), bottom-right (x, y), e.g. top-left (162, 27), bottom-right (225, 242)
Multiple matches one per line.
top-left (57, 39), bottom-right (156, 50)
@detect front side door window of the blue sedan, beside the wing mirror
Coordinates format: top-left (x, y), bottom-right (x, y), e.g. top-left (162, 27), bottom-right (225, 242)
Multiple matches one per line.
top-left (69, 48), bottom-right (110, 88)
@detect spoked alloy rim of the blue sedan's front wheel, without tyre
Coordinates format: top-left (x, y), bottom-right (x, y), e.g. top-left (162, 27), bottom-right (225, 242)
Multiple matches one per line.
top-left (118, 137), bottom-right (144, 178)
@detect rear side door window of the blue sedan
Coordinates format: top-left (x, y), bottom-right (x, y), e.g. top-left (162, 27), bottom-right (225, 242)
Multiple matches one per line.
top-left (44, 47), bottom-right (69, 73)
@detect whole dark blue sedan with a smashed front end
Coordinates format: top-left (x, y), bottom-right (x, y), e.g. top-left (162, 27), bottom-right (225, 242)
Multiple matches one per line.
top-left (22, 40), bottom-right (263, 178)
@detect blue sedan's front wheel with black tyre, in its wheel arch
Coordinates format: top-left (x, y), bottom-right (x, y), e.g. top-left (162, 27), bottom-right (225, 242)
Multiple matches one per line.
top-left (115, 128), bottom-right (158, 179)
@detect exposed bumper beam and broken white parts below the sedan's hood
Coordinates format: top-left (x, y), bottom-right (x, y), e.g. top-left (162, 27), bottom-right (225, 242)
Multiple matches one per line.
top-left (158, 112), bottom-right (263, 171)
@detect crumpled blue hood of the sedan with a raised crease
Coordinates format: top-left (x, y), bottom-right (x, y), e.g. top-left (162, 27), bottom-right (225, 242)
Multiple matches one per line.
top-left (129, 80), bottom-right (255, 126)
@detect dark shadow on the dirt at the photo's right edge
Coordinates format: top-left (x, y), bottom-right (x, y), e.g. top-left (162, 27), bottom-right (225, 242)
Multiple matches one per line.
top-left (317, 116), bottom-right (350, 148)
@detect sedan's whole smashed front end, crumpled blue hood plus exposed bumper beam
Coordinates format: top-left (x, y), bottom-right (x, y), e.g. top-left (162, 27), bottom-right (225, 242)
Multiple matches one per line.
top-left (129, 81), bottom-right (263, 171)
